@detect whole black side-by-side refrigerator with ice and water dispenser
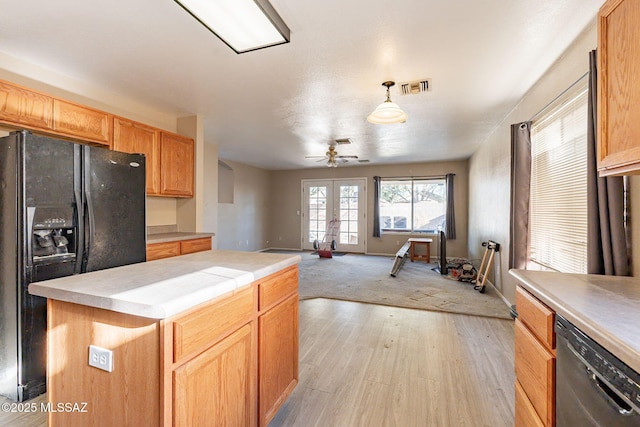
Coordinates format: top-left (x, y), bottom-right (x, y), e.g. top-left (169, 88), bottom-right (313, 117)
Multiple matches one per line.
top-left (0, 131), bottom-right (146, 402)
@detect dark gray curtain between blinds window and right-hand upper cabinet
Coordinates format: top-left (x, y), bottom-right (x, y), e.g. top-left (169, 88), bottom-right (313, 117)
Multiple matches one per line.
top-left (587, 50), bottom-right (629, 276)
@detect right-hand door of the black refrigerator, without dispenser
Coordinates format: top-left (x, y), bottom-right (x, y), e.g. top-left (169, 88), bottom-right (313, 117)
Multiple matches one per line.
top-left (83, 147), bottom-right (146, 272)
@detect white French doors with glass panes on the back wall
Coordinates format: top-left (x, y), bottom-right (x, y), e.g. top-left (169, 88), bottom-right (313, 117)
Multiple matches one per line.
top-left (302, 178), bottom-right (367, 252)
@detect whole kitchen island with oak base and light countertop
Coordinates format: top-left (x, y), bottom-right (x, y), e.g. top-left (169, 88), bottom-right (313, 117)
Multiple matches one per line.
top-left (29, 250), bottom-right (300, 426)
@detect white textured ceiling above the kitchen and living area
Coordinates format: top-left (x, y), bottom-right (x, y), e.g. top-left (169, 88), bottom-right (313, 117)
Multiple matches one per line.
top-left (0, 0), bottom-right (602, 169)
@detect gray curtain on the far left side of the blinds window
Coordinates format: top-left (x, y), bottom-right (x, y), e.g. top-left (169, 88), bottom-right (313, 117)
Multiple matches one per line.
top-left (509, 122), bottom-right (531, 269)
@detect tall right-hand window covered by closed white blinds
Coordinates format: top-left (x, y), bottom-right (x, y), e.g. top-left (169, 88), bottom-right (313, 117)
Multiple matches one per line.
top-left (529, 78), bottom-right (588, 273)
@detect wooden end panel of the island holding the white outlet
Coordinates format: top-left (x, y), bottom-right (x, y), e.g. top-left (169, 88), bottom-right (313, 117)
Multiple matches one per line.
top-left (47, 299), bottom-right (161, 427)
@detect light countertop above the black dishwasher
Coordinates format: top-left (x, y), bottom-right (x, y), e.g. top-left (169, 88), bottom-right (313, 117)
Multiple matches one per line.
top-left (509, 270), bottom-right (640, 372)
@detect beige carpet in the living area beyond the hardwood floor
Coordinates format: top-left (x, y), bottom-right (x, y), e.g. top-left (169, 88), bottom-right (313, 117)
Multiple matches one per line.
top-left (276, 252), bottom-right (511, 319)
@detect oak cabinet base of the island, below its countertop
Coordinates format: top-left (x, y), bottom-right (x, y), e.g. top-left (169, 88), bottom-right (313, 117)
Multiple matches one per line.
top-left (47, 266), bottom-right (298, 427)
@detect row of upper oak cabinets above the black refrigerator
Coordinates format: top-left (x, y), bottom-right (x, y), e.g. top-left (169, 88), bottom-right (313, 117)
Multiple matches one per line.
top-left (0, 80), bottom-right (195, 198)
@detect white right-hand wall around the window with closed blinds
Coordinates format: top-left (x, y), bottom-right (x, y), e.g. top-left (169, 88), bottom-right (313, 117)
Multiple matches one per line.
top-left (469, 19), bottom-right (597, 303)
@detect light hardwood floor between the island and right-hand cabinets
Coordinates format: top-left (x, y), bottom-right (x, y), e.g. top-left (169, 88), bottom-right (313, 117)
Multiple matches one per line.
top-left (269, 299), bottom-right (514, 427)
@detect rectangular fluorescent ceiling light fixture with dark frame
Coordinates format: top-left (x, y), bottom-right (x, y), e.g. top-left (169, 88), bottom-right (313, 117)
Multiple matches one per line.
top-left (175, 0), bottom-right (290, 53)
